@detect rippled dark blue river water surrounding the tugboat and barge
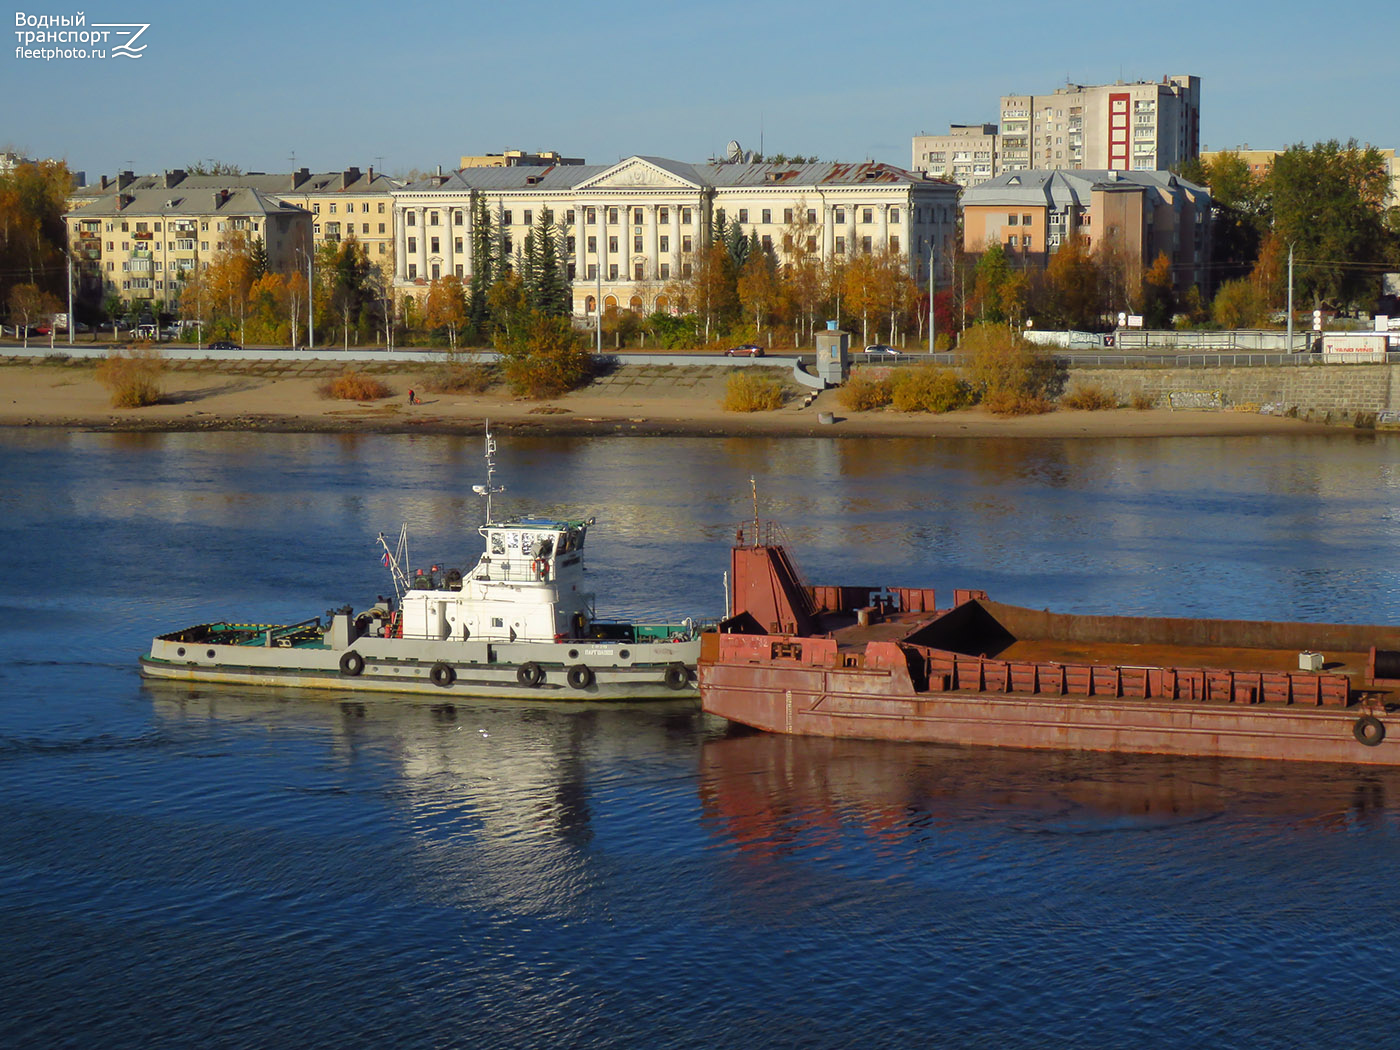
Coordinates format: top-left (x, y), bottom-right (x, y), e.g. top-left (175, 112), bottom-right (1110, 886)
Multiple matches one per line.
top-left (0, 431), bottom-right (1400, 1047)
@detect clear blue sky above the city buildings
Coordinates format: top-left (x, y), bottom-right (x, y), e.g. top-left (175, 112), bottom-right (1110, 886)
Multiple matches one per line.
top-left (0, 0), bottom-right (1400, 178)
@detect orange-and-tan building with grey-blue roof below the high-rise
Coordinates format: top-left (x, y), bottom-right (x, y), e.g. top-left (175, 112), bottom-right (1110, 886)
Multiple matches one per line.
top-left (962, 169), bottom-right (1211, 290)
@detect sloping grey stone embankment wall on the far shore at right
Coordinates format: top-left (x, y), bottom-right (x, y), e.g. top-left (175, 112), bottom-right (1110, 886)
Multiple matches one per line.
top-left (1065, 364), bottom-right (1400, 423)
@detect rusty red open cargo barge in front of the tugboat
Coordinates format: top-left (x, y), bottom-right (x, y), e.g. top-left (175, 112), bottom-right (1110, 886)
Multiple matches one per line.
top-left (699, 522), bottom-right (1400, 766)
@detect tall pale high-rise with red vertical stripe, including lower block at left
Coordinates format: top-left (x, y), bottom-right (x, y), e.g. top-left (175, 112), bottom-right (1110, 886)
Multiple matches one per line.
top-left (914, 76), bottom-right (1201, 186)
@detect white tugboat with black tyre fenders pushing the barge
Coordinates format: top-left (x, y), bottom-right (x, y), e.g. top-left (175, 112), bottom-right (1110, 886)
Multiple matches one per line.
top-left (141, 431), bottom-right (700, 700)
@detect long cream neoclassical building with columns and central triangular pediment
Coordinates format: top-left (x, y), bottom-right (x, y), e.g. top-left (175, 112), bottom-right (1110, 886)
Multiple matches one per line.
top-left (393, 157), bottom-right (959, 315)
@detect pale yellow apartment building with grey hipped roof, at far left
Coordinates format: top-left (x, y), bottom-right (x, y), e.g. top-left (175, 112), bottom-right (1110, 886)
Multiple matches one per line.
top-left (64, 188), bottom-right (311, 302)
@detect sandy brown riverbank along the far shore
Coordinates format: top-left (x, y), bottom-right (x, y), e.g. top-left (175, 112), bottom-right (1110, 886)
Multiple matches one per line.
top-left (0, 360), bottom-right (1329, 438)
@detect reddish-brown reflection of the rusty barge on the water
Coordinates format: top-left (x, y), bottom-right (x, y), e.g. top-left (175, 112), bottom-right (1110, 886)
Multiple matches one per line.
top-left (700, 728), bottom-right (1400, 855)
